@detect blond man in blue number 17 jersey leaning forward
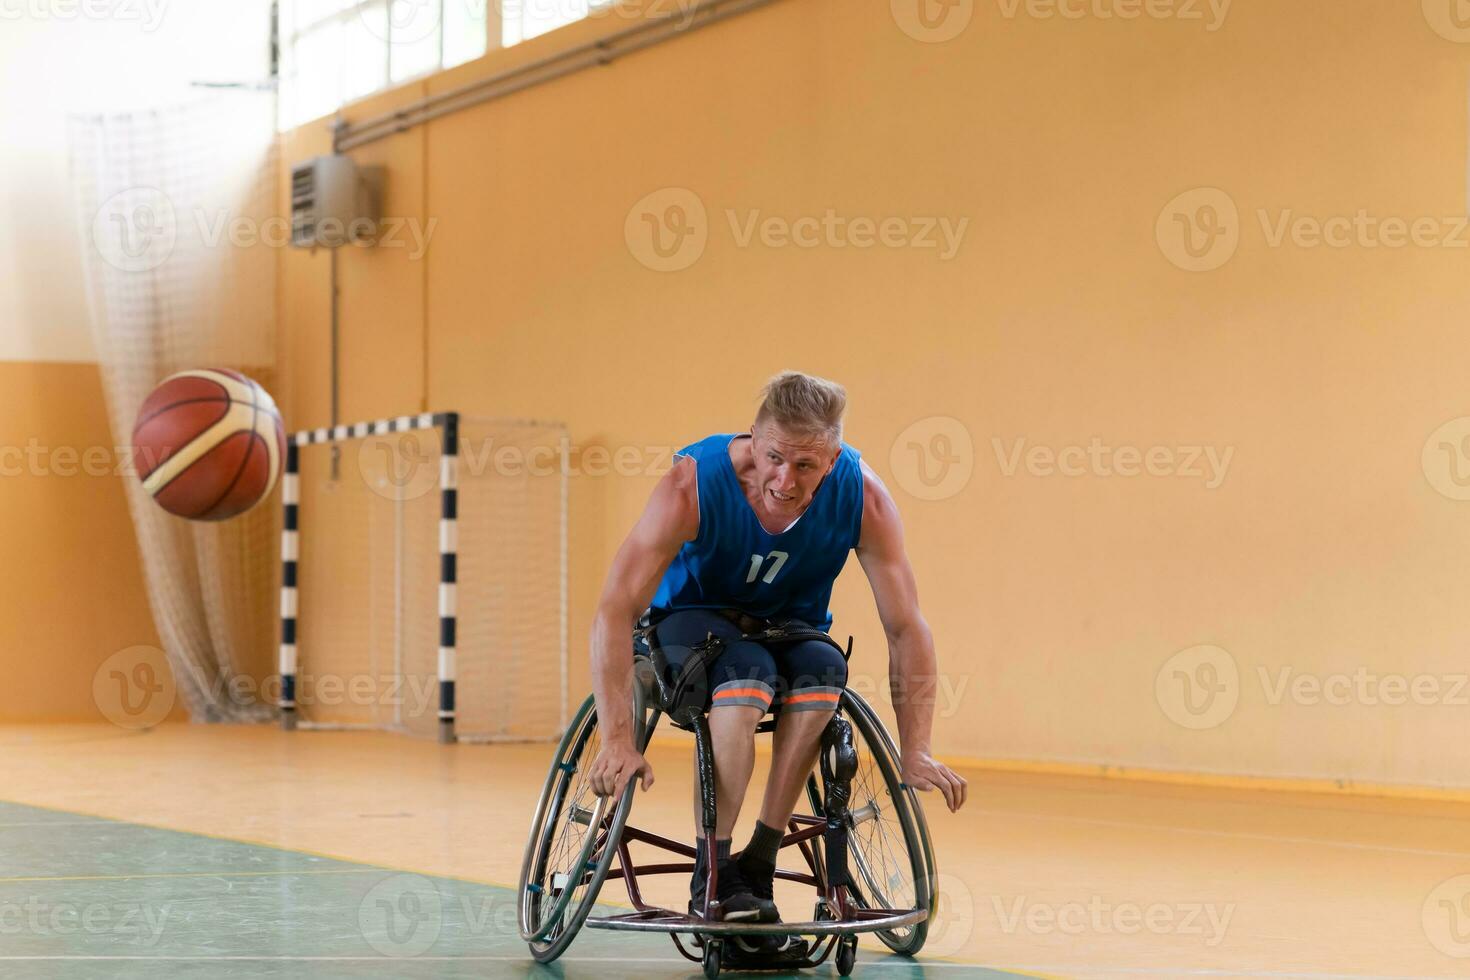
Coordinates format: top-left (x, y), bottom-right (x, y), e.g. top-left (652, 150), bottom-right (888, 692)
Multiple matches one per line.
top-left (588, 372), bottom-right (966, 923)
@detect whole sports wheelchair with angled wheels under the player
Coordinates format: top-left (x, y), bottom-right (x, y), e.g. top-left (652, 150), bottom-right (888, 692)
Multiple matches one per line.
top-left (517, 616), bottom-right (938, 980)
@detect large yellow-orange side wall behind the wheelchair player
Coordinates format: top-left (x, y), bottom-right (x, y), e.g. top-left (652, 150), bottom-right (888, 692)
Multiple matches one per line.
top-left (281, 0), bottom-right (1470, 786)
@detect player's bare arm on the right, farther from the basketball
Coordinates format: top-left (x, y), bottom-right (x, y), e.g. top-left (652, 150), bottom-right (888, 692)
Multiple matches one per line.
top-left (857, 463), bottom-right (967, 811)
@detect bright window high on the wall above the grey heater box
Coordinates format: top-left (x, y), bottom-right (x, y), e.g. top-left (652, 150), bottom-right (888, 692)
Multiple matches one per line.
top-left (281, 0), bottom-right (616, 129)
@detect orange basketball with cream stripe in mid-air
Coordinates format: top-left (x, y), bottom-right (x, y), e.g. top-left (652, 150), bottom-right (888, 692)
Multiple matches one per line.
top-left (132, 369), bottom-right (285, 520)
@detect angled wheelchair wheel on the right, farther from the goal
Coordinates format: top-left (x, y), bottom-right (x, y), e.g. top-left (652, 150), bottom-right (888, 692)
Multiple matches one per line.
top-left (807, 691), bottom-right (935, 956)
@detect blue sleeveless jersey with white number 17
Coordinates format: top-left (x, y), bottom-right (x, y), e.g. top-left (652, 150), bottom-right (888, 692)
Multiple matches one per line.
top-left (651, 433), bottom-right (863, 629)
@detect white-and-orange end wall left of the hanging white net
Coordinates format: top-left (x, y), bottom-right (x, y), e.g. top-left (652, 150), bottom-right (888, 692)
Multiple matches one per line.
top-left (0, 0), bottom-right (273, 723)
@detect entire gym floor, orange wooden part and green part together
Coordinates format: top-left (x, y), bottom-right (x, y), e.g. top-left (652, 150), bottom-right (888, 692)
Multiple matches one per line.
top-left (0, 724), bottom-right (1470, 980)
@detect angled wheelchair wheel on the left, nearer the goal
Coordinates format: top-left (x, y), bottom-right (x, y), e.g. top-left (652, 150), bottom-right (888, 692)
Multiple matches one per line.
top-left (517, 661), bottom-right (659, 962)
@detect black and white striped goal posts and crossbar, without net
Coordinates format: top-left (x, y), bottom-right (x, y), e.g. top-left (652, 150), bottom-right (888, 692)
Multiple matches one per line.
top-left (279, 411), bottom-right (460, 742)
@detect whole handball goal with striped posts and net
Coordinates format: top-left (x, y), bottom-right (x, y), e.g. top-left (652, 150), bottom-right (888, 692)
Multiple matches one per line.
top-left (281, 413), bottom-right (567, 741)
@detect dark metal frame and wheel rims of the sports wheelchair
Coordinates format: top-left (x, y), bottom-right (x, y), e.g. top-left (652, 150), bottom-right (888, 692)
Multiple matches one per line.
top-left (520, 630), bottom-right (935, 980)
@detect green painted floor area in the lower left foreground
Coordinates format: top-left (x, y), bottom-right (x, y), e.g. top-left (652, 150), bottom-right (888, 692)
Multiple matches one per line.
top-left (0, 802), bottom-right (1014, 980)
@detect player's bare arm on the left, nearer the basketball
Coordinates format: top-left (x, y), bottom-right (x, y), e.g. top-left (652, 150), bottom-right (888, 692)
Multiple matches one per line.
top-left (588, 457), bottom-right (700, 796)
